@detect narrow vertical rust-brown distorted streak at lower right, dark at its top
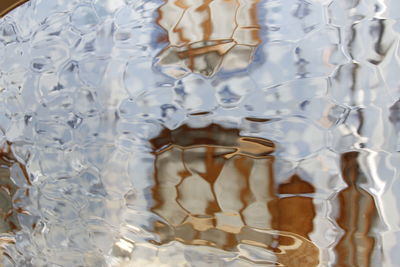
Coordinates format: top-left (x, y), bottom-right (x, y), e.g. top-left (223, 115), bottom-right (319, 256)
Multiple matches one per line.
top-left (335, 152), bottom-right (378, 267)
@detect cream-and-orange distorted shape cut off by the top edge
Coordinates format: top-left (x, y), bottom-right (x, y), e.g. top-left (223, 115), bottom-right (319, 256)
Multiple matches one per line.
top-left (157, 0), bottom-right (261, 78)
